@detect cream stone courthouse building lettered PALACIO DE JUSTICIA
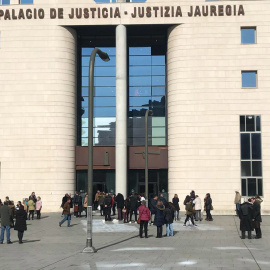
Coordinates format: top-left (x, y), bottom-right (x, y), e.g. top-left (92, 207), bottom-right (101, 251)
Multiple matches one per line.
top-left (0, 0), bottom-right (270, 214)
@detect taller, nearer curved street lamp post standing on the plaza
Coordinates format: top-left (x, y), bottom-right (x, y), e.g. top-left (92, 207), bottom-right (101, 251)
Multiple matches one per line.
top-left (83, 48), bottom-right (110, 253)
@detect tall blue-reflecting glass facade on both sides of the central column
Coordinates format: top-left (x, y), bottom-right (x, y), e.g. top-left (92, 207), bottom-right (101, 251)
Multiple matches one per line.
top-left (79, 47), bottom-right (167, 146)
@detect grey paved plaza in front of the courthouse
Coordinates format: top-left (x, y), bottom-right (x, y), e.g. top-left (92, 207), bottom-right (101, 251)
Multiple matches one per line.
top-left (0, 213), bottom-right (270, 270)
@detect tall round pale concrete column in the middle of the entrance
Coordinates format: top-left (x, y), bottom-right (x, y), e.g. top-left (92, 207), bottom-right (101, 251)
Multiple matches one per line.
top-left (115, 25), bottom-right (127, 197)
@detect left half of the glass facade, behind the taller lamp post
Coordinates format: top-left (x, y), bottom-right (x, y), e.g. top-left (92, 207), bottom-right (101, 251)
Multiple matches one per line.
top-left (80, 48), bottom-right (116, 146)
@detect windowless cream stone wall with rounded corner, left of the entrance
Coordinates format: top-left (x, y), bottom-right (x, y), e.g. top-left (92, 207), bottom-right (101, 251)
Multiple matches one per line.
top-left (0, 25), bottom-right (76, 211)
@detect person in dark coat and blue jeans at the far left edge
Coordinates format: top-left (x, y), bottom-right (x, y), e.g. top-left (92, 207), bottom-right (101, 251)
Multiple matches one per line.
top-left (0, 201), bottom-right (13, 244)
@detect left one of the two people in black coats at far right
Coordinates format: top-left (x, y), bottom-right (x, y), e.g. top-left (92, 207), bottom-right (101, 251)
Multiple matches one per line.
top-left (238, 199), bottom-right (252, 239)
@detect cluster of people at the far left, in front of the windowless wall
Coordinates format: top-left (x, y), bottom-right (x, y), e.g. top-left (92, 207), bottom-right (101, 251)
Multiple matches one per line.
top-left (0, 192), bottom-right (42, 244)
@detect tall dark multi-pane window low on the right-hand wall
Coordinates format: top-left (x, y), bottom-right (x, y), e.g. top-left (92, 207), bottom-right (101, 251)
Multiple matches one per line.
top-left (240, 115), bottom-right (263, 196)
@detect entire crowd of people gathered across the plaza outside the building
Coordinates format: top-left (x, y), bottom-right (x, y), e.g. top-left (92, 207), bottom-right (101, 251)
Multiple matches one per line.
top-left (0, 190), bottom-right (262, 244)
